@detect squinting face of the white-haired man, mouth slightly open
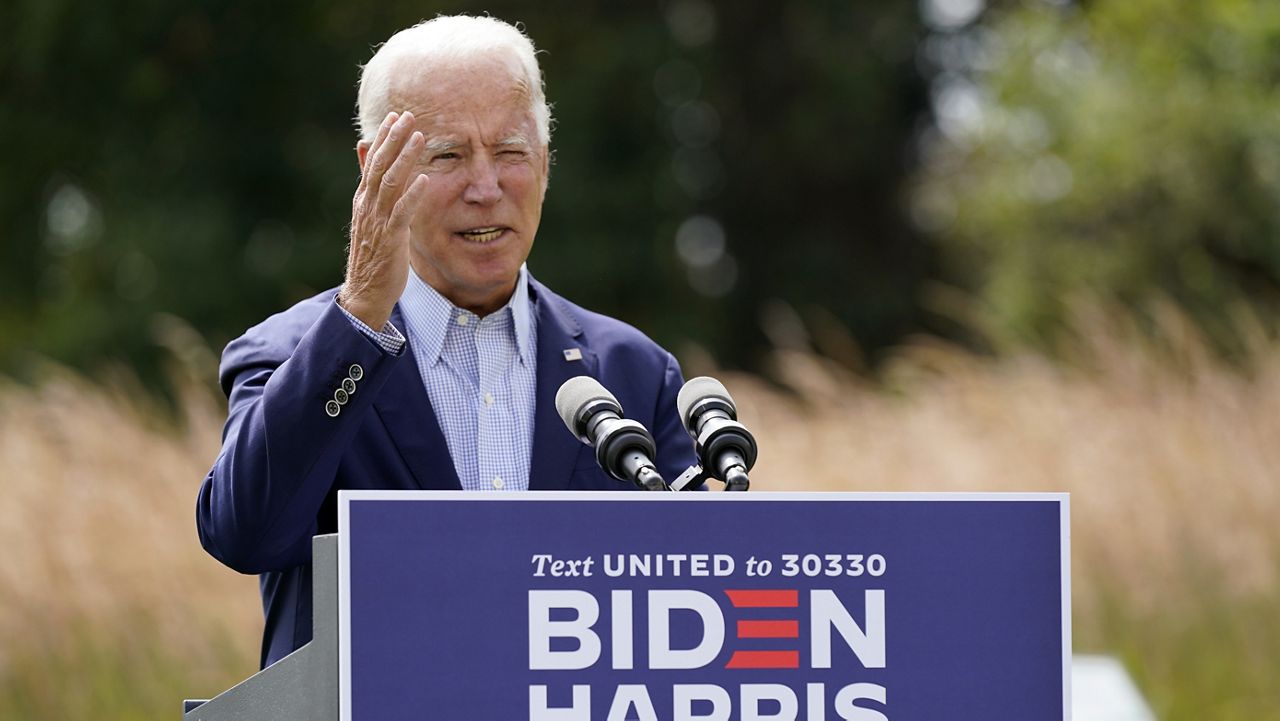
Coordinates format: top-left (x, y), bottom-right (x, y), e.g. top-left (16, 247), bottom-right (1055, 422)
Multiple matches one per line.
top-left (373, 58), bottom-right (548, 315)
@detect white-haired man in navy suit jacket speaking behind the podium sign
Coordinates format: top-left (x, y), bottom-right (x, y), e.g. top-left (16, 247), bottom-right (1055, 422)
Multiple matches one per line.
top-left (197, 17), bottom-right (694, 666)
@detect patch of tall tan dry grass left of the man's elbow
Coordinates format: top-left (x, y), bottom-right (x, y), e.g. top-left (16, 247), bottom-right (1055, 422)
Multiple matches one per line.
top-left (0, 368), bottom-right (261, 720)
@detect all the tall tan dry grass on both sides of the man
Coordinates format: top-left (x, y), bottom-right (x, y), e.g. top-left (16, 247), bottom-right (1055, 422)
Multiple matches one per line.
top-left (0, 303), bottom-right (1280, 721)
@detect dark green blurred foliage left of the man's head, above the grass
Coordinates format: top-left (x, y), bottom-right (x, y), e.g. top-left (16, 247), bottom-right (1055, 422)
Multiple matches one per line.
top-left (0, 1), bottom-right (369, 381)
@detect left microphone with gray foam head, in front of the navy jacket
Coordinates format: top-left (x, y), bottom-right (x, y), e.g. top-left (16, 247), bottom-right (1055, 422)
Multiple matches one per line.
top-left (556, 375), bottom-right (671, 490)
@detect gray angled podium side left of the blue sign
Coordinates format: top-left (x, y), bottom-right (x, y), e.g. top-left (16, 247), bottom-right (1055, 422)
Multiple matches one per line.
top-left (182, 534), bottom-right (338, 721)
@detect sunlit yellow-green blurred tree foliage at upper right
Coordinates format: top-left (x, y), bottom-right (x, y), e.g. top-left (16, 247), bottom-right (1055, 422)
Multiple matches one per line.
top-left (915, 0), bottom-right (1280, 353)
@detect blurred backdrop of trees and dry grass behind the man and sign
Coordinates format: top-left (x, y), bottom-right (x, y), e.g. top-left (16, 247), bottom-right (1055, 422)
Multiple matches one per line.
top-left (0, 0), bottom-right (1280, 721)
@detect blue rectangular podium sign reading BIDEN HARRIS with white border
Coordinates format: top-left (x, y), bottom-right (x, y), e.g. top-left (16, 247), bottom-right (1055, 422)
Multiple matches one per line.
top-left (338, 490), bottom-right (1071, 721)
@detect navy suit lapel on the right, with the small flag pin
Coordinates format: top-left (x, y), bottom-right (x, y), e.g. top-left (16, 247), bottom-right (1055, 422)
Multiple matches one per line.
top-left (529, 278), bottom-right (596, 490)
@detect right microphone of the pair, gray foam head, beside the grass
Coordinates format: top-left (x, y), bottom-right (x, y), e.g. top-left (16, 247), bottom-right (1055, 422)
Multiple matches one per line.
top-left (676, 375), bottom-right (756, 490)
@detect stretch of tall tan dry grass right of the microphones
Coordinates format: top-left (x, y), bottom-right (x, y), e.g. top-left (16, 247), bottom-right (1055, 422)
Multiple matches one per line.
top-left (724, 306), bottom-right (1280, 721)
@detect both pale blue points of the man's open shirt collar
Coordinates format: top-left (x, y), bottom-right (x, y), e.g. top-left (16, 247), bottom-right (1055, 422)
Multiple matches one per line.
top-left (399, 264), bottom-right (534, 365)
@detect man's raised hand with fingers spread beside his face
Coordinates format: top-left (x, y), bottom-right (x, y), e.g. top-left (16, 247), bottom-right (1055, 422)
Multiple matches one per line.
top-left (338, 113), bottom-right (428, 330)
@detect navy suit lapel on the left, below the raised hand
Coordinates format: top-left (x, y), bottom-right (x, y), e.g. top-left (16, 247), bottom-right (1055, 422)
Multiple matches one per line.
top-left (374, 305), bottom-right (462, 490)
